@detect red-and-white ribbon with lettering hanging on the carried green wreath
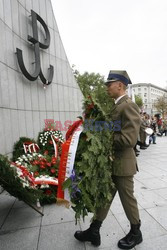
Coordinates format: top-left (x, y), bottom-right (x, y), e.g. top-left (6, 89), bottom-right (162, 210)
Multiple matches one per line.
top-left (57, 120), bottom-right (83, 202)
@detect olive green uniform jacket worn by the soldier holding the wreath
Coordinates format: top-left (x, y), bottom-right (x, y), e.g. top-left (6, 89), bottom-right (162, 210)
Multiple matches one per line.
top-left (112, 95), bottom-right (141, 176)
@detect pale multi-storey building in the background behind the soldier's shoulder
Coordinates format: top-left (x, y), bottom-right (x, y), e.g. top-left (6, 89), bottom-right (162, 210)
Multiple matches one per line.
top-left (130, 83), bottom-right (167, 115)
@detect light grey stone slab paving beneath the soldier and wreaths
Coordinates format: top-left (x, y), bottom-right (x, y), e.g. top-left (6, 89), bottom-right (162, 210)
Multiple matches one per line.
top-left (0, 136), bottom-right (167, 250)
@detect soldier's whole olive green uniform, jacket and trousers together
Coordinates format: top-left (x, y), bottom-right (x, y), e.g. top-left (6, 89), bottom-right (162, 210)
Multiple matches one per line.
top-left (96, 95), bottom-right (141, 224)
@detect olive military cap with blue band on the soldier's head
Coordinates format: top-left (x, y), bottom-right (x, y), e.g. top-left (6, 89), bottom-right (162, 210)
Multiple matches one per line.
top-left (105, 70), bottom-right (132, 86)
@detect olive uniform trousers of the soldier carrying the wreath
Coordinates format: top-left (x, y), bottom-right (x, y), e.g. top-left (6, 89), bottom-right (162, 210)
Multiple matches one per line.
top-left (95, 176), bottom-right (140, 224)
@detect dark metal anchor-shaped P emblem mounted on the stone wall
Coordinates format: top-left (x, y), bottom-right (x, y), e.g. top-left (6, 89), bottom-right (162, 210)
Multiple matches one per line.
top-left (16, 10), bottom-right (54, 85)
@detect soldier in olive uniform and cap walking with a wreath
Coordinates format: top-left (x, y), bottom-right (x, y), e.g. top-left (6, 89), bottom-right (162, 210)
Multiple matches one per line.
top-left (74, 70), bottom-right (143, 249)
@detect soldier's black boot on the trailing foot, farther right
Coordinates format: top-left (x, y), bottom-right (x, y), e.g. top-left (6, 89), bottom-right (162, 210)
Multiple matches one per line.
top-left (118, 223), bottom-right (143, 249)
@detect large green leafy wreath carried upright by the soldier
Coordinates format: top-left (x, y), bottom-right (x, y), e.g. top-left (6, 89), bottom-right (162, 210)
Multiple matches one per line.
top-left (63, 74), bottom-right (114, 221)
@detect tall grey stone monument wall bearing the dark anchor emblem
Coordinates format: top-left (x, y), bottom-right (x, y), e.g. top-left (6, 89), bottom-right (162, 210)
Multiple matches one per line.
top-left (0, 0), bottom-right (82, 155)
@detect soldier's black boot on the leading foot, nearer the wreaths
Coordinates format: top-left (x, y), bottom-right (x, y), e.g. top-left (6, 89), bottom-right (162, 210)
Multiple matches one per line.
top-left (74, 220), bottom-right (102, 246)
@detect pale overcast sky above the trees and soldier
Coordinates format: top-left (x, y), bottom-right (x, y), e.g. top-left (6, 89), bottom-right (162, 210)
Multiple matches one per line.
top-left (51, 0), bottom-right (167, 88)
